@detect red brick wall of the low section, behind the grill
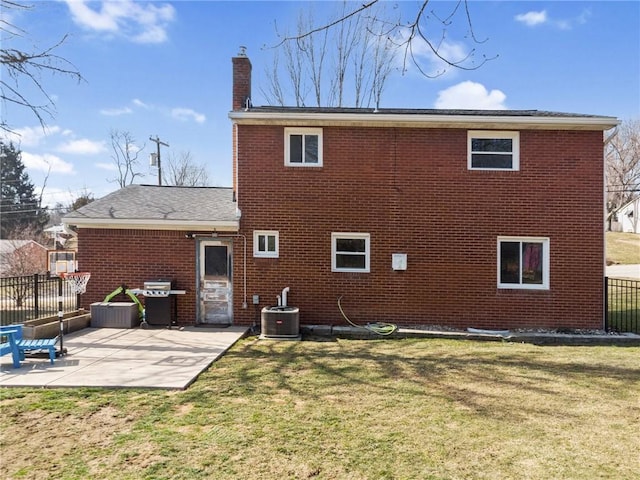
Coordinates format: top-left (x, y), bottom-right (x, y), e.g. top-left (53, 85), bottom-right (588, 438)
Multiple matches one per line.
top-left (78, 228), bottom-right (197, 325)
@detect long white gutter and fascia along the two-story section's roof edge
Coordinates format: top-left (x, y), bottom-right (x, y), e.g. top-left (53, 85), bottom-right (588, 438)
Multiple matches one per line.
top-left (229, 110), bottom-right (620, 130)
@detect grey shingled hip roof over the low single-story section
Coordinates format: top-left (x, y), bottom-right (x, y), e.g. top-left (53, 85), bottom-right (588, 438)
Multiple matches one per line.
top-left (63, 185), bottom-right (239, 231)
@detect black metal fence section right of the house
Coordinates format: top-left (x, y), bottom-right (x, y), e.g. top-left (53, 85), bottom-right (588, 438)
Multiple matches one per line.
top-left (604, 277), bottom-right (640, 333)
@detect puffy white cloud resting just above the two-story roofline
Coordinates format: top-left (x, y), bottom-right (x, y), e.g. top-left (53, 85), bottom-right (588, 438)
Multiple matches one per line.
top-left (435, 81), bottom-right (507, 110)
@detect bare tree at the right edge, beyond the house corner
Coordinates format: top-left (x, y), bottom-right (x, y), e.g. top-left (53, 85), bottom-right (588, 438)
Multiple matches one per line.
top-left (605, 119), bottom-right (640, 231)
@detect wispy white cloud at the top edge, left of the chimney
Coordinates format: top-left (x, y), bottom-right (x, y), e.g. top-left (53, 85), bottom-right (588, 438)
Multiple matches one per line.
top-left (65, 0), bottom-right (175, 43)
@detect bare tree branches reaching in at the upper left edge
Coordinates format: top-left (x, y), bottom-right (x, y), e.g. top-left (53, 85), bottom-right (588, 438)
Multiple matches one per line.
top-left (0, 0), bottom-right (83, 132)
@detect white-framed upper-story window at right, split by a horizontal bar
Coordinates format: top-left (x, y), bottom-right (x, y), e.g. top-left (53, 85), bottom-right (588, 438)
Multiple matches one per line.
top-left (467, 130), bottom-right (520, 170)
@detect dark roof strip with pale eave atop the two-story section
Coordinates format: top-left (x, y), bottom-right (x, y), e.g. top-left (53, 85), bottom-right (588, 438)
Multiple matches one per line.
top-left (229, 107), bottom-right (620, 130)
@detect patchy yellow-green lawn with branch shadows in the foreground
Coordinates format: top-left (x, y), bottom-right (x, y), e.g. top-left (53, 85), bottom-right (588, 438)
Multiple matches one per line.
top-left (0, 337), bottom-right (640, 480)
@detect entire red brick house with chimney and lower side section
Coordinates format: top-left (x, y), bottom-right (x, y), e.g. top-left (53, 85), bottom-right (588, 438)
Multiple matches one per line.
top-left (64, 54), bottom-right (618, 329)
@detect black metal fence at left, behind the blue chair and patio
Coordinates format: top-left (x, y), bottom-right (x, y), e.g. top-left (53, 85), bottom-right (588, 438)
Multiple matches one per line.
top-left (0, 274), bottom-right (79, 325)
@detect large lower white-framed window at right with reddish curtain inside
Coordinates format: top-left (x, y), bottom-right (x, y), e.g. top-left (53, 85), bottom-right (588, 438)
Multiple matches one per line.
top-left (498, 237), bottom-right (549, 290)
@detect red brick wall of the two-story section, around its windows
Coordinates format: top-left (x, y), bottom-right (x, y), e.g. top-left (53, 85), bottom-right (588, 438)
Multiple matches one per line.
top-left (235, 125), bottom-right (604, 328)
